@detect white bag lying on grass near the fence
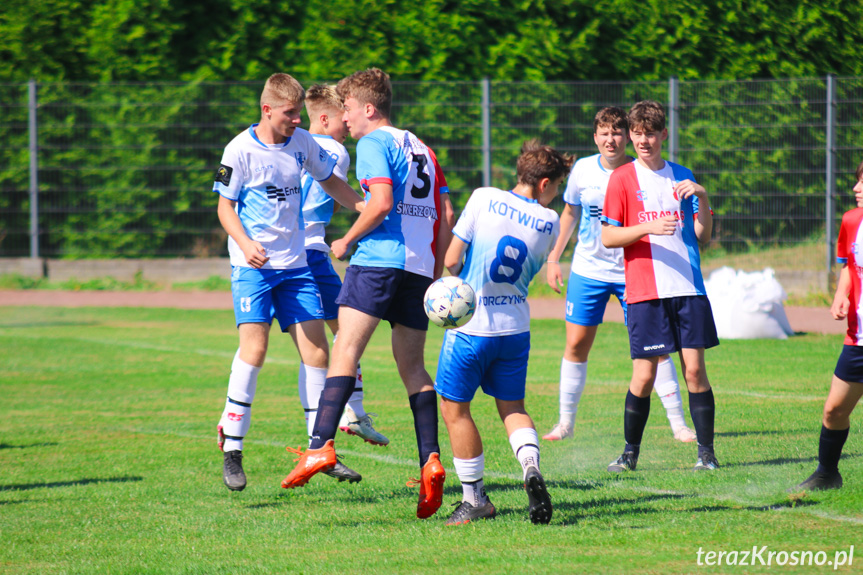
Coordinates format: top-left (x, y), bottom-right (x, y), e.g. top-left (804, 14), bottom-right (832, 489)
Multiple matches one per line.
top-left (704, 267), bottom-right (794, 339)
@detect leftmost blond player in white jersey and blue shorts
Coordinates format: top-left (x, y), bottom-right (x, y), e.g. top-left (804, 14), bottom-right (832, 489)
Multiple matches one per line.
top-left (213, 74), bottom-right (363, 491)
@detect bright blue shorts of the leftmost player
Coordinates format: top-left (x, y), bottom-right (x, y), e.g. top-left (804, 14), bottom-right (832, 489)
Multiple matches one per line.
top-left (231, 266), bottom-right (324, 331)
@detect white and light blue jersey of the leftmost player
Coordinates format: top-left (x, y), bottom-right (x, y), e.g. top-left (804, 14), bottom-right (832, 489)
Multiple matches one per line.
top-left (213, 124), bottom-right (346, 269)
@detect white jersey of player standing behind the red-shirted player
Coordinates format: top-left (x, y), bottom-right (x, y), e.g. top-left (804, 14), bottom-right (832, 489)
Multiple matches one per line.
top-left (563, 154), bottom-right (625, 283)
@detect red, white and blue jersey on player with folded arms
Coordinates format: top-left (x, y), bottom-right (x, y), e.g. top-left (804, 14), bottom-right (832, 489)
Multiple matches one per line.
top-left (601, 162), bottom-right (707, 303)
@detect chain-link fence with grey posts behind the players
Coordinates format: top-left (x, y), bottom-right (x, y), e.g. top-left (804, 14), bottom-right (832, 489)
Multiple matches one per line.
top-left (0, 77), bottom-right (863, 276)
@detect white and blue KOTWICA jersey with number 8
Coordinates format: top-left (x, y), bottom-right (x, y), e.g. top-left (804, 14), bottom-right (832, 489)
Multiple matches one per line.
top-left (453, 188), bottom-right (560, 336)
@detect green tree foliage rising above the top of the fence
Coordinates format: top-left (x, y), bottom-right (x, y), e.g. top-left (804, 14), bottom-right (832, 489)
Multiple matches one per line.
top-left (0, 0), bottom-right (863, 82)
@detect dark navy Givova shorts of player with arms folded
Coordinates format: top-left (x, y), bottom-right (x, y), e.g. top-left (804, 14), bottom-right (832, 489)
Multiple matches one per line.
top-left (627, 295), bottom-right (719, 359)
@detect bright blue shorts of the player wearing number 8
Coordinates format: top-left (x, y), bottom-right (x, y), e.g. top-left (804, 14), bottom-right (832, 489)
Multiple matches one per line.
top-left (435, 330), bottom-right (530, 403)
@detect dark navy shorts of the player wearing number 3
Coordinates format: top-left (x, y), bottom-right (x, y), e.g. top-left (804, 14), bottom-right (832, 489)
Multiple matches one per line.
top-left (336, 266), bottom-right (432, 331)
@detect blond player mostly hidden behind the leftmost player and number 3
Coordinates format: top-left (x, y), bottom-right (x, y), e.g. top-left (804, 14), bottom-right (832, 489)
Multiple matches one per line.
top-left (300, 84), bottom-right (390, 450)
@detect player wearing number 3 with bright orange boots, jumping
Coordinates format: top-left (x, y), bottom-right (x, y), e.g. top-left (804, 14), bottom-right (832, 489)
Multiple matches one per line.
top-left (282, 68), bottom-right (451, 518)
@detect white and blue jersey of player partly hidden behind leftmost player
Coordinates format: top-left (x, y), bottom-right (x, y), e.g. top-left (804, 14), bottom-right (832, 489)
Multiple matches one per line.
top-left (302, 134), bottom-right (351, 253)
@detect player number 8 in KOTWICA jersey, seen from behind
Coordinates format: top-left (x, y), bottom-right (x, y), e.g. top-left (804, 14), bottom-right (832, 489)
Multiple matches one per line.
top-left (435, 141), bottom-right (572, 525)
